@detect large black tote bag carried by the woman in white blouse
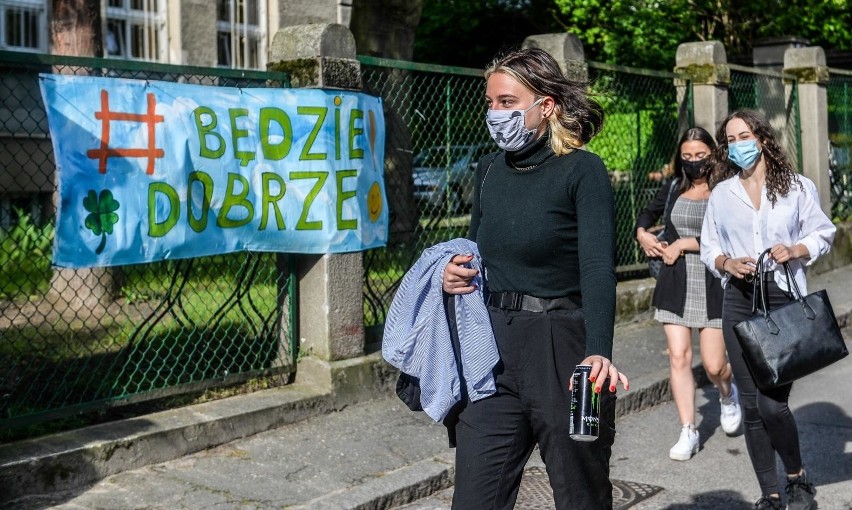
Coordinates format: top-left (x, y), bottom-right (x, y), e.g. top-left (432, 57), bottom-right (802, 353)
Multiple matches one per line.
top-left (734, 250), bottom-right (849, 390)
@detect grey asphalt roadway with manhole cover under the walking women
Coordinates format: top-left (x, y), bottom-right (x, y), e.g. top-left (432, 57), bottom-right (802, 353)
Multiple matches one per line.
top-left (398, 342), bottom-right (852, 510)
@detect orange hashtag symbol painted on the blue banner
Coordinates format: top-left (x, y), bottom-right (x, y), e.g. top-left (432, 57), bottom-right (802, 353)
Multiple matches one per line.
top-left (86, 90), bottom-right (163, 175)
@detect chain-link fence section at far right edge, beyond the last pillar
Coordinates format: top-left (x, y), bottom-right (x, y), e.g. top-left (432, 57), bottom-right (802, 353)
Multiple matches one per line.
top-left (826, 69), bottom-right (852, 221)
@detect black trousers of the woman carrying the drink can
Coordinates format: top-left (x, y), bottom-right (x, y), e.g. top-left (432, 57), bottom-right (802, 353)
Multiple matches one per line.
top-left (453, 307), bottom-right (615, 510)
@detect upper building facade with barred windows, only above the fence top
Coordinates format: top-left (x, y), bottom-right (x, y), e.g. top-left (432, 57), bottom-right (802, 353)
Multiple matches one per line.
top-left (0, 0), bottom-right (352, 69)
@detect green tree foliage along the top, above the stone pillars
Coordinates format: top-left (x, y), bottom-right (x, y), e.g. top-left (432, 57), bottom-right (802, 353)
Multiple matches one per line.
top-left (414, 0), bottom-right (852, 70)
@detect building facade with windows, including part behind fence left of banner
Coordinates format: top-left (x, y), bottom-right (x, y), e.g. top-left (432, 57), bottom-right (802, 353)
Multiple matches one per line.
top-left (0, 0), bottom-right (351, 229)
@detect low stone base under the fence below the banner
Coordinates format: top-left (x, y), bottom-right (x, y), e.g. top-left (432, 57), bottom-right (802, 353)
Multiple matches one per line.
top-left (0, 385), bottom-right (334, 505)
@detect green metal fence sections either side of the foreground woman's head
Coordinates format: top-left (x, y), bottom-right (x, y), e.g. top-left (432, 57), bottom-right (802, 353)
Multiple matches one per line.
top-left (358, 56), bottom-right (678, 329)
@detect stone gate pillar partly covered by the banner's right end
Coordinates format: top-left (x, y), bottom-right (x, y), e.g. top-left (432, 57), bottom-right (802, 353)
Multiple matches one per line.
top-left (267, 24), bottom-right (382, 401)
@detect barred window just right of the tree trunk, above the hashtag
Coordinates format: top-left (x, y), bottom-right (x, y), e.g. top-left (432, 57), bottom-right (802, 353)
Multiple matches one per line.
top-left (104, 0), bottom-right (166, 60)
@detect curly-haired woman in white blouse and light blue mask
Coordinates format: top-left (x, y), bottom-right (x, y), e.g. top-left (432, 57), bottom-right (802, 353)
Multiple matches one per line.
top-left (701, 110), bottom-right (835, 510)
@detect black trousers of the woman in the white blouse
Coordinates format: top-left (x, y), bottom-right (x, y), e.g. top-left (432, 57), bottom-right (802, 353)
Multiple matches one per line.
top-left (722, 276), bottom-right (802, 496)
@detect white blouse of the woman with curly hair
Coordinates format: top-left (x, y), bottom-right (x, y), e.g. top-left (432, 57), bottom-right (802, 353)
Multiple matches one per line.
top-left (701, 175), bottom-right (837, 294)
